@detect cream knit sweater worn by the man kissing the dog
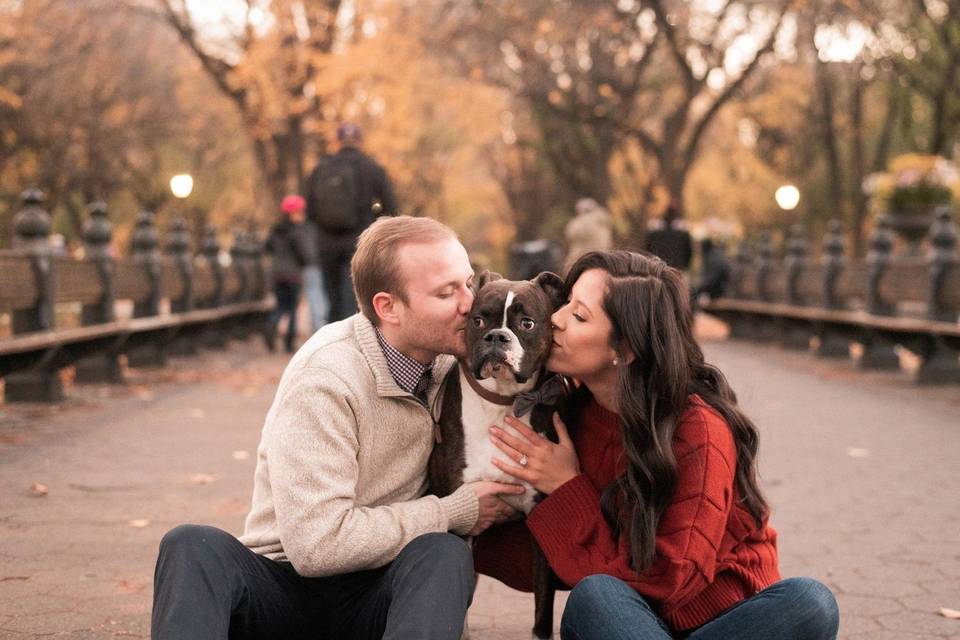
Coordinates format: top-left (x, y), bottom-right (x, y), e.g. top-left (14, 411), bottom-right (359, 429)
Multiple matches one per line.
top-left (240, 314), bottom-right (479, 577)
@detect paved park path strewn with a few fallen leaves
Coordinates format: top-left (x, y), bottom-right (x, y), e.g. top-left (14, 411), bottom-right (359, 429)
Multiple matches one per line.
top-left (0, 328), bottom-right (960, 640)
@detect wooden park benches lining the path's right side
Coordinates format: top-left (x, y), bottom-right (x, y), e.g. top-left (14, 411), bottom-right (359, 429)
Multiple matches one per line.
top-left (702, 210), bottom-right (960, 383)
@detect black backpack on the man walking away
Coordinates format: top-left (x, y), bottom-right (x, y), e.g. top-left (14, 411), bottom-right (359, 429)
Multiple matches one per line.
top-left (310, 154), bottom-right (363, 234)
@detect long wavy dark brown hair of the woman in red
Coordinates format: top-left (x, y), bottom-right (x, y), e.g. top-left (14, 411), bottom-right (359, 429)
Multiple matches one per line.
top-left (566, 251), bottom-right (769, 572)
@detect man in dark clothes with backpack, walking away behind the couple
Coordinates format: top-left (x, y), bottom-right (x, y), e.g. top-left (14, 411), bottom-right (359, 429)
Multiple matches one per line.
top-left (307, 123), bottom-right (397, 322)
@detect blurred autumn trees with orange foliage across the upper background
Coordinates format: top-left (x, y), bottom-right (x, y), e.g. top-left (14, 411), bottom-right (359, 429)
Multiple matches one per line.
top-left (0, 0), bottom-right (960, 267)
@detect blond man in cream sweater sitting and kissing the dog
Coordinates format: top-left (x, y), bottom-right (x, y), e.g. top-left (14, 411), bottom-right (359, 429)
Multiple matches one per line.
top-left (153, 217), bottom-right (523, 640)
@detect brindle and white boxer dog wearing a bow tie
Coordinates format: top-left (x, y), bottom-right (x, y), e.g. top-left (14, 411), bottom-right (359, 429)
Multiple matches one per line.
top-left (429, 271), bottom-right (565, 639)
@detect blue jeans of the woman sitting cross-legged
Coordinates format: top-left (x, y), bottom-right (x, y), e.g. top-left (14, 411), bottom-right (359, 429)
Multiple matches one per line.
top-left (560, 575), bottom-right (840, 640)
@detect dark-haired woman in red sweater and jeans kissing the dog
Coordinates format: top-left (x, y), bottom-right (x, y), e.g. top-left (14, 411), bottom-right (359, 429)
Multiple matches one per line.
top-left (476, 251), bottom-right (839, 640)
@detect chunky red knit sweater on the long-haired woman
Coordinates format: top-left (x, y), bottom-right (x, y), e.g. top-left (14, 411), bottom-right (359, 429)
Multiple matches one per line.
top-left (474, 396), bottom-right (780, 631)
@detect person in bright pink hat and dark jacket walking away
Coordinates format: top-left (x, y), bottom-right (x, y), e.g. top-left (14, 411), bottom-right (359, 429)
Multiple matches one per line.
top-left (265, 196), bottom-right (312, 353)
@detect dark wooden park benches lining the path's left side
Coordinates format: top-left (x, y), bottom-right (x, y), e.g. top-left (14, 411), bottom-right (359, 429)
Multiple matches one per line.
top-left (0, 191), bottom-right (273, 402)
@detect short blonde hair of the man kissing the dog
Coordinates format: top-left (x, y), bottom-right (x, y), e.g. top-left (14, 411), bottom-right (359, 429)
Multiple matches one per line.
top-left (350, 216), bottom-right (457, 326)
